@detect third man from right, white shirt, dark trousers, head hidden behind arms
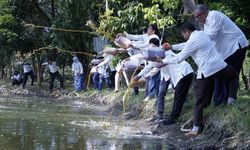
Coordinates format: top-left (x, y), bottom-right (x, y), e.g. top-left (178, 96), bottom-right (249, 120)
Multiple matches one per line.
top-left (156, 50), bottom-right (194, 125)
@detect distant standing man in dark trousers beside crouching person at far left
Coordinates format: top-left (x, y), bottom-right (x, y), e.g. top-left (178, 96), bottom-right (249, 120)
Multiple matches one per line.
top-left (22, 62), bottom-right (35, 89)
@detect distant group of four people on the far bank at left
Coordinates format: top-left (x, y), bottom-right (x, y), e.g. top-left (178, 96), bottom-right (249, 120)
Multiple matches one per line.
top-left (11, 56), bottom-right (85, 93)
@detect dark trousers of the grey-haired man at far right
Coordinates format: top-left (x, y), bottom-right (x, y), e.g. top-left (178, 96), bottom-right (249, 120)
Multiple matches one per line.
top-left (213, 48), bottom-right (247, 105)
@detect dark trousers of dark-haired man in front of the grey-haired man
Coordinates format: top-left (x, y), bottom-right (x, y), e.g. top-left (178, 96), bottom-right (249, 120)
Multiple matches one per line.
top-left (194, 65), bottom-right (238, 126)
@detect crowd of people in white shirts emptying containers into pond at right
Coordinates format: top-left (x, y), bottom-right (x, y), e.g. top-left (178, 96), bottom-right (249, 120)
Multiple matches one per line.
top-left (89, 4), bottom-right (249, 137)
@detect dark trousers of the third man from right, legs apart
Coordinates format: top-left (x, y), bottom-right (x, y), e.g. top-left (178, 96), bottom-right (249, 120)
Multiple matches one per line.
top-left (157, 73), bottom-right (193, 120)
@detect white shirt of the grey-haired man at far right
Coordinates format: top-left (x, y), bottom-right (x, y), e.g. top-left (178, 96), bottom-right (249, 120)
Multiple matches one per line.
top-left (204, 11), bottom-right (249, 60)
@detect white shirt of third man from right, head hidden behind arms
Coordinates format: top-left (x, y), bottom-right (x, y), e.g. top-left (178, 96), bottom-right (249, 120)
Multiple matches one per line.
top-left (161, 50), bottom-right (194, 87)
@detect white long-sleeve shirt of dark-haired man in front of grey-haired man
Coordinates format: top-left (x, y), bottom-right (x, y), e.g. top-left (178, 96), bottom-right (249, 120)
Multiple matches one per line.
top-left (162, 30), bottom-right (227, 79)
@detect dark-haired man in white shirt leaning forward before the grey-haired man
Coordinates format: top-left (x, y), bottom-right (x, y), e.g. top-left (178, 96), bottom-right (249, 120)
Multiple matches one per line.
top-left (162, 23), bottom-right (237, 137)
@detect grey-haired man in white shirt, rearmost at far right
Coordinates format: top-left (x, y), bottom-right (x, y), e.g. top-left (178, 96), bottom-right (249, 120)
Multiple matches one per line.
top-left (194, 4), bottom-right (249, 105)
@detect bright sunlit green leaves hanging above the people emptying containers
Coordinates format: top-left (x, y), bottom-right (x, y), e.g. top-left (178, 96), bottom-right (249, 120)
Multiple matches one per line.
top-left (99, 0), bottom-right (179, 38)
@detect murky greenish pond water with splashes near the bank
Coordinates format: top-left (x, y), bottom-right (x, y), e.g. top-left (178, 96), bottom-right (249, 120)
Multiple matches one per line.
top-left (0, 98), bottom-right (175, 150)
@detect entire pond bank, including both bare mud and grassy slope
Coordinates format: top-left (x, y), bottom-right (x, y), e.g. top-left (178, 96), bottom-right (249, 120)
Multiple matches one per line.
top-left (0, 81), bottom-right (250, 149)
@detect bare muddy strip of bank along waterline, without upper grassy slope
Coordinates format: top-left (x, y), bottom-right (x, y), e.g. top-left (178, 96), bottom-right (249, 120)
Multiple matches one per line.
top-left (0, 84), bottom-right (250, 149)
